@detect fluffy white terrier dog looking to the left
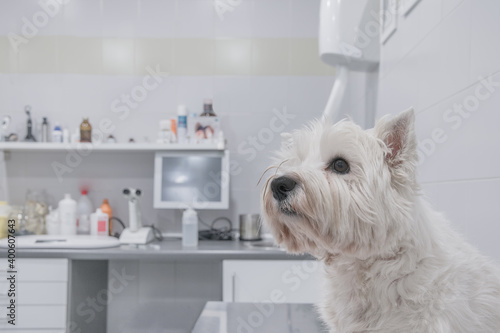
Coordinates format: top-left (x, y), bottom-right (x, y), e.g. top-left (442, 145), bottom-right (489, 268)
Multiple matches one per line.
top-left (262, 110), bottom-right (500, 333)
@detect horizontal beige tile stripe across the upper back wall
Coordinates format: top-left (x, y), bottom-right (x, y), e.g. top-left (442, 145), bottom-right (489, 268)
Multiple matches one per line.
top-left (0, 36), bottom-right (334, 76)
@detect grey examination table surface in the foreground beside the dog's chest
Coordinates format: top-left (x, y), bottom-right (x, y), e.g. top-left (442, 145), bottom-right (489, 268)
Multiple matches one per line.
top-left (192, 302), bottom-right (327, 333)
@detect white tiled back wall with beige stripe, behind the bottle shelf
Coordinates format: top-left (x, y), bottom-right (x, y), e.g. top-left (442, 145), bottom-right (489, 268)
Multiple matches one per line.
top-left (0, 0), bottom-right (334, 231)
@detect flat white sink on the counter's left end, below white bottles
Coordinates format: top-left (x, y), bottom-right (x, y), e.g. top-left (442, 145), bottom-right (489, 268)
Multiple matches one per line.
top-left (0, 235), bottom-right (120, 249)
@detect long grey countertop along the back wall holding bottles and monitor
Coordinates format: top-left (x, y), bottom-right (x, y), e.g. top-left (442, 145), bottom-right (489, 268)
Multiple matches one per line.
top-left (0, 239), bottom-right (314, 261)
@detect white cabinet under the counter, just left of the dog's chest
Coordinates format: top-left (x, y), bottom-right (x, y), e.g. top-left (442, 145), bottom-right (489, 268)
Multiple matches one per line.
top-left (222, 260), bottom-right (323, 303)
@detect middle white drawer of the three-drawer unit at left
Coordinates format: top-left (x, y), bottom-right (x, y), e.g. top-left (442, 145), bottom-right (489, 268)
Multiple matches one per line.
top-left (0, 282), bottom-right (68, 309)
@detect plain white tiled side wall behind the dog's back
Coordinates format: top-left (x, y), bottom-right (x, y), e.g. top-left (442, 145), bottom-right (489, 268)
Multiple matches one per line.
top-left (377, 0), bottom-right (500, 260)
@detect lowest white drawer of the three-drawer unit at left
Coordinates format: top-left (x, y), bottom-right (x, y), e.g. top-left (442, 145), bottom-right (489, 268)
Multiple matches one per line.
top-left (0, 305), bottom-right (66, 333)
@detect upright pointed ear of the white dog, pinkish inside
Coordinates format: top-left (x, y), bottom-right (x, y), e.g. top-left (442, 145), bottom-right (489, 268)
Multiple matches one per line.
top-left (375, 108), bottom-right (418, 177)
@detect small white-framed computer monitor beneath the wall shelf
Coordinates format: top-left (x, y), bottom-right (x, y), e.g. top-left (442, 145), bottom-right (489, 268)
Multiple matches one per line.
top-left (154, 150), bottom-right (230, 209)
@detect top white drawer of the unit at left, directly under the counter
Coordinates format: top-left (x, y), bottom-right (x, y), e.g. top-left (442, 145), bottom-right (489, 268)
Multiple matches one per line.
top-left (0, 258), bottom-right (68, 282)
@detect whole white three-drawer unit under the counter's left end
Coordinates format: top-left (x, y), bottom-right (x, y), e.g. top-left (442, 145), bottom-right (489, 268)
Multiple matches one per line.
top-left (0, 258), bottom-right (69, 333)
